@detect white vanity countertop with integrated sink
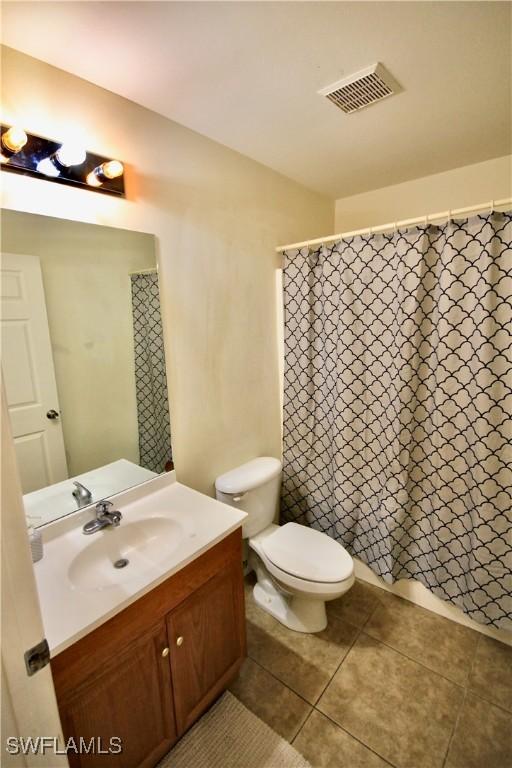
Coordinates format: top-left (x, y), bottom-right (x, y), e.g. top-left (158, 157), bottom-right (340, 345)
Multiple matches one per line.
top-left (34, 473), bottom-right (246, 657)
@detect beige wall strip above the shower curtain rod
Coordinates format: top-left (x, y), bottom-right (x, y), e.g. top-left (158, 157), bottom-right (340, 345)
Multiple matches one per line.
top-left (334, 155), bottom-right (512, 232)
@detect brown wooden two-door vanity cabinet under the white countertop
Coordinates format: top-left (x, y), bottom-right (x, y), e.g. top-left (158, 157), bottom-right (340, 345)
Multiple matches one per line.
top-left (51, 530), bottom-right (245, 768)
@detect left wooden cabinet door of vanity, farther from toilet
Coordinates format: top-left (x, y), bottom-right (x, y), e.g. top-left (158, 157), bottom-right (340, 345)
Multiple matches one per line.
top-left (59, 621), bottom-right (176, 768)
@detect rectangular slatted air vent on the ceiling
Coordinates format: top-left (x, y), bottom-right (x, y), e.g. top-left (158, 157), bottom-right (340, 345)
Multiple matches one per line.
top-left (318, 63), bottom-right (401, 114)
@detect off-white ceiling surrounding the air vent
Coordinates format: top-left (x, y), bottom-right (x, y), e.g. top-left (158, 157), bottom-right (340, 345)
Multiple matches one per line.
top-left (3, 2), bottom-right (512, 197)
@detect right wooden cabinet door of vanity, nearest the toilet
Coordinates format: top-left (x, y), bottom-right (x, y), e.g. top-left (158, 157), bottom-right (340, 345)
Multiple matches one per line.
top-left (168, 562), bottom-right (245, 736)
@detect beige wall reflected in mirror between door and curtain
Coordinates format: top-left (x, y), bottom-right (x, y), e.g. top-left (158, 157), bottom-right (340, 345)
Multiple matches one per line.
top-left (2, 210), bottom-right (156, 477)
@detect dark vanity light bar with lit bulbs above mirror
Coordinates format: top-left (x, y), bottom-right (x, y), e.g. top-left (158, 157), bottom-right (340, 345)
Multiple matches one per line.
top-left (0, 125), bottom-right (125, 197)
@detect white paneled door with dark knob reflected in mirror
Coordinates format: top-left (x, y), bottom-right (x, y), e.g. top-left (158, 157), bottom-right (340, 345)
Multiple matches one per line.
top-left (0, 254), bottom-right (68, 493)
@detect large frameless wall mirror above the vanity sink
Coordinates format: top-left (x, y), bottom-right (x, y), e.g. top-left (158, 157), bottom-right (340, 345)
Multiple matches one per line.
top-left (0, 210), bottom-right (173, 526)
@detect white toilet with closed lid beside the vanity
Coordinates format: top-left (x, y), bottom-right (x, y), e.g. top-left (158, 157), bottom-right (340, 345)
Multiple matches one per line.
top-left (215, 457), bottom-right (354, 632)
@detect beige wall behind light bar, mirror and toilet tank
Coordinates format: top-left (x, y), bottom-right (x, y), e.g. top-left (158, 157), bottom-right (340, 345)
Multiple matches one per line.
top-left (2, 48), bottom-right (334, 493)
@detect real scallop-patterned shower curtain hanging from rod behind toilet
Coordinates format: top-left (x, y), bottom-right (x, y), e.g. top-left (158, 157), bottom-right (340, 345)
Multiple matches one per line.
top-left (281, 213), bottom-right (512, 630)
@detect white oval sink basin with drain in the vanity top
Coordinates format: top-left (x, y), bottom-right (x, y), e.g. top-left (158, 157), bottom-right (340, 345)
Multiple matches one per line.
top-left (68, 517), bottom-right (185, 589)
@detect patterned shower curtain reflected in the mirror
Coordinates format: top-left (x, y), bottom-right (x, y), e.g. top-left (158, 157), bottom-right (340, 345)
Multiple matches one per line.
top-left (130, 272), bottom-right (172, 473)
